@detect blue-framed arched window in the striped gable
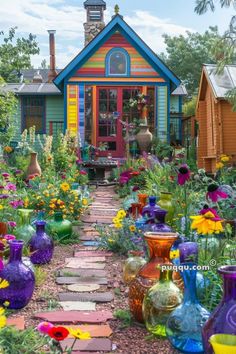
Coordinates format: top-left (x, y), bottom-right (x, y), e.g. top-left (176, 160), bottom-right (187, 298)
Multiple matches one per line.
top-left (106, 48), bottom-right (130, 76)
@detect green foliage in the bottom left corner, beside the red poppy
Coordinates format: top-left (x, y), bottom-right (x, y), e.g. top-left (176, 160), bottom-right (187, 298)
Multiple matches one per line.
top-left (0, 326), bottom-right (50, 354)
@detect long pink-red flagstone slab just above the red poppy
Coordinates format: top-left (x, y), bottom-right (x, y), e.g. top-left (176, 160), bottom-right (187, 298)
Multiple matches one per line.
top-left (33, 311), bottom-right (113, 324)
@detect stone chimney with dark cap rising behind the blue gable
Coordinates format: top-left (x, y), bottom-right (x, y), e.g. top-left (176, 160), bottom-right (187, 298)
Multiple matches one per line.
top-left (84, 0), bottom-right (106, 46)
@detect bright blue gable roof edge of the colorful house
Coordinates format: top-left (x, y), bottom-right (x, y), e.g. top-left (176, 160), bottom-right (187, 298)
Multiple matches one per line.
top-left (54, 14), bottom-right (180, 91)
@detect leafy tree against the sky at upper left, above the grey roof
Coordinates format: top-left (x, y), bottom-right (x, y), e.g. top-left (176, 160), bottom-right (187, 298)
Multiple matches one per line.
top-left (0, 27), bottom-right (39, 82)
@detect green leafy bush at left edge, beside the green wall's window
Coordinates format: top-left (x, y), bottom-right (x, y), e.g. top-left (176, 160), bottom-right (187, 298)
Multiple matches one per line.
top-left (0, 77), bottom-right (17, 145)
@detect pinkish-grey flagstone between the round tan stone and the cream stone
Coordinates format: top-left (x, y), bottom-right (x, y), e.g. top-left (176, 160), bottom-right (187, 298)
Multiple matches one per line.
top-left (58, 292), bottom-right (114, 302)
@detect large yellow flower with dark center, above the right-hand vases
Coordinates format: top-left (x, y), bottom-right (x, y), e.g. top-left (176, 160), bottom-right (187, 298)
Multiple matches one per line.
top-left (190, 211), bottom-right (223, 235)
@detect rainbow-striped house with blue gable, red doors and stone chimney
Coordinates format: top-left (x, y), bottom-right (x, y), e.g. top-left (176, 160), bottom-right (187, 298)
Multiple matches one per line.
top-left (1, 0), bottom-right (186, 157)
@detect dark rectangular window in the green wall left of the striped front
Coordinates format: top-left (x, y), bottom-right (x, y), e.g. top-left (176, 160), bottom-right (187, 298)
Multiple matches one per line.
top-left (22, 96), bottom-right (45, 134)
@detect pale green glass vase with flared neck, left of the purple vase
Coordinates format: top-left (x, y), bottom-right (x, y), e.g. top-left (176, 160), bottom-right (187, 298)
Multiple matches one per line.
top-left (15, 209), bottom-right (35, 244)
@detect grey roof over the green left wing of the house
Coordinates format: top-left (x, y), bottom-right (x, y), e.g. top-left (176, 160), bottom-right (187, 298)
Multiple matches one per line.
top-left (0, 82), bottom-right (61, 96)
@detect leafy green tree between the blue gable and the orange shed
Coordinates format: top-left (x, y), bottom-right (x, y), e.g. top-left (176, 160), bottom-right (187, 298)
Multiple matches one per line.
top-left (161, 26), bottom-right (222, 98)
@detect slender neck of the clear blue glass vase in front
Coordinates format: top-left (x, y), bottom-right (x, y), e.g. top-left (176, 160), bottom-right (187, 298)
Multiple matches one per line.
top-left (181, 263), bottom-right (198, 304)
